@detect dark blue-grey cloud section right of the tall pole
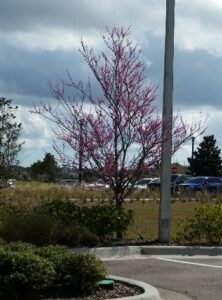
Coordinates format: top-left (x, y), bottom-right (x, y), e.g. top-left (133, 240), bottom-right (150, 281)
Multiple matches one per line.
top-left (174, 49), bottom-right (222, 107)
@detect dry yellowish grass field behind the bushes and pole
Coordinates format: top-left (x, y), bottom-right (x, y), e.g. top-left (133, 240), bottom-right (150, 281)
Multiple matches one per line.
top-left (0, 182), bottom-right (222, 240)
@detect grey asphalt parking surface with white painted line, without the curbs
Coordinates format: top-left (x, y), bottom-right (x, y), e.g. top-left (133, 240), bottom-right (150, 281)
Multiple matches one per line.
top-left (105, 256), bottom-right (222, 300)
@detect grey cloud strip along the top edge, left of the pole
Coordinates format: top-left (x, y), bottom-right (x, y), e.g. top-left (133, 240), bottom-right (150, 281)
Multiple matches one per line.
top-left (0, 0), bottom-right (165, 32)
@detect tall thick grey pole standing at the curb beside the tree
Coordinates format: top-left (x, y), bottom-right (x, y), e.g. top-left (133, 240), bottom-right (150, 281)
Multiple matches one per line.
top-left (159, 0), bottom-right (175, 242)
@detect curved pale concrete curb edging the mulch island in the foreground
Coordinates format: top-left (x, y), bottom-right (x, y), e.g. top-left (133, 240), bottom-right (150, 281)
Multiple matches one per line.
top-left (108, 275), bottom-right (161, 300)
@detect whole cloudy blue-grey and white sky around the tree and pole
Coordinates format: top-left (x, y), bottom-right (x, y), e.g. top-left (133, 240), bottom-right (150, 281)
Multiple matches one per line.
top-left (0, 0), bottom-right (222, 166)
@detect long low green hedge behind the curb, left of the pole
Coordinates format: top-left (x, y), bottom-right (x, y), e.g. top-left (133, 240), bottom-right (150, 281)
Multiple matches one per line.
top-left (0, 200), bottom-right (133, 247)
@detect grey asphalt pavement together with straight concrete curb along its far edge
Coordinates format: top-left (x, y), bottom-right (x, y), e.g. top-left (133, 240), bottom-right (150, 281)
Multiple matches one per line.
top-left (73, 246), bottom-right (222, 300)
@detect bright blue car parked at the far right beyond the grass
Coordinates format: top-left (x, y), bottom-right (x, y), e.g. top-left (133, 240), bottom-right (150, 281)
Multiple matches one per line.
top-left (178, 176), bottom-right (222, 194)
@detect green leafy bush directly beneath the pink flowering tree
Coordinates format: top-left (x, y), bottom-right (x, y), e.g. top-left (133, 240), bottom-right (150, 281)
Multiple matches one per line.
top-left (37, 200), bottom-right (133, 244)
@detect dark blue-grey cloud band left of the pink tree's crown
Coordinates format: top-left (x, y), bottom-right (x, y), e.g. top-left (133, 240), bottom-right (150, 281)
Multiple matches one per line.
top-left (0, 40), bottom-right (87, 105)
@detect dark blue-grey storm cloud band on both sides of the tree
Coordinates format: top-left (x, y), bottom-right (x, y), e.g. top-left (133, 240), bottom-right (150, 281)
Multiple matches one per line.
top-left (0, 30), bottom-right (222, 111)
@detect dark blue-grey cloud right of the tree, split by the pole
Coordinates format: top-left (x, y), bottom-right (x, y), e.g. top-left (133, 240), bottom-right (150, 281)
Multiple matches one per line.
top-left (142, 35), bottom-right (222, 108)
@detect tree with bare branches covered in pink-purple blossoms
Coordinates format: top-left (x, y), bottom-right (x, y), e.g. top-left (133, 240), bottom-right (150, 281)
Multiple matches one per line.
top-left (34, 27), bottom-right (205, 206)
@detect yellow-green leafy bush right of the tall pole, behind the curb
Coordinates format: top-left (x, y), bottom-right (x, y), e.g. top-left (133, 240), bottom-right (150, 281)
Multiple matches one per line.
top-left (176, 205), bottom-right (222, 245)
